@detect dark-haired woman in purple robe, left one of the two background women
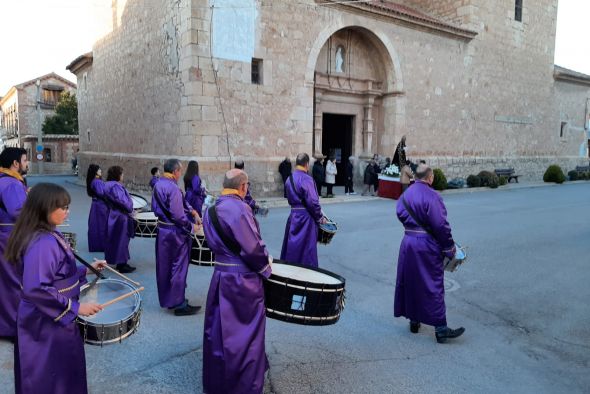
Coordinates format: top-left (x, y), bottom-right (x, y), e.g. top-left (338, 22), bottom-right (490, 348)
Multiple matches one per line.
top-left (86, 164), bottom-right (109, 252)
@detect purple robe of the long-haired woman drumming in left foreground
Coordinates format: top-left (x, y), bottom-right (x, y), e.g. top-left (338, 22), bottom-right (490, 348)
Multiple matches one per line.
top-left (15, 232), bottom-right (87, 394)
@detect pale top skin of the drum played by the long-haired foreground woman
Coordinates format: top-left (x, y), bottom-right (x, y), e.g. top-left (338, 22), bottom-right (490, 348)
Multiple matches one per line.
top-left (80, 279), bottom-right (141, 325)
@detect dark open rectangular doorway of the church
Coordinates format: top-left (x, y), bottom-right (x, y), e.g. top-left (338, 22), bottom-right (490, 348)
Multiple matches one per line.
top-left (322, 113), bottom-right (354, 186)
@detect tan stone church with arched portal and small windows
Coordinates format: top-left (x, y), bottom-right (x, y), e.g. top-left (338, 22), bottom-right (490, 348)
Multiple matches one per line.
top-left (68, 0), bottom-right (590, 195)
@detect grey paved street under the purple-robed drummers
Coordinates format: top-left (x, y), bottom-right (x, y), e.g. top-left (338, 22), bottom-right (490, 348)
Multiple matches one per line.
top-left (0, 178), bottom-right (590, 394)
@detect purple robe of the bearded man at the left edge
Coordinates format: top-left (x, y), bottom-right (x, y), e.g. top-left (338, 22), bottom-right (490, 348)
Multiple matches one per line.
top-left (0, 174), bottom-right (27, 337)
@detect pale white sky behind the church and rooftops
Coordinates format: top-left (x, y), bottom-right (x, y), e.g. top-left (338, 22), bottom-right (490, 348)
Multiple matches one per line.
top-left (0, 0), bottom-right (590, 96)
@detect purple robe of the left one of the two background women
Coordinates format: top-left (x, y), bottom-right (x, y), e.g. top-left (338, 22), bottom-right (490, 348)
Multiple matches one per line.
top-left (88, 178), bottom-right (109, 252)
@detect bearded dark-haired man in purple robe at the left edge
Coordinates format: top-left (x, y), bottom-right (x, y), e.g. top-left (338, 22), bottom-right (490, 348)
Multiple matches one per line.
top-left (0, 148), bottom-right (29, 338)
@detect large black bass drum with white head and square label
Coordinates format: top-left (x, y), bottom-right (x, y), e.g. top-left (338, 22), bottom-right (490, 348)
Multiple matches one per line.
top-left (264, 260), bottom-right (345, 326)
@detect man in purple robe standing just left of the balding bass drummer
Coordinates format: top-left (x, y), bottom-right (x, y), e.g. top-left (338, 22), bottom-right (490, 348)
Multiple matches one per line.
top-left (152, 159), bottom-right (201, 316)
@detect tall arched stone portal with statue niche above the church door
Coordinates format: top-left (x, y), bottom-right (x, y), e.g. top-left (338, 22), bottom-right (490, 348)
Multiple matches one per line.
top-left (313, 26), bottom-right (403, 184)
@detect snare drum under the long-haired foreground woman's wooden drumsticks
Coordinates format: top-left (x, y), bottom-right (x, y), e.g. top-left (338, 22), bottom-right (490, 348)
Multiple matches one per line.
top-left (77, 279), bottom-right (141, 346)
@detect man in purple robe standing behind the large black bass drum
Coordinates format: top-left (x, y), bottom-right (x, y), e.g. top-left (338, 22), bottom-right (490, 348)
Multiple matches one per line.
top-left (281, 153), bottom-right (326, 268)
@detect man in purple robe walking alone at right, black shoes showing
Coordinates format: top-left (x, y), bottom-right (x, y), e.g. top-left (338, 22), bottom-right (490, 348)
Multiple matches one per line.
top-left (394, 164), bottom-right (465, 343)
